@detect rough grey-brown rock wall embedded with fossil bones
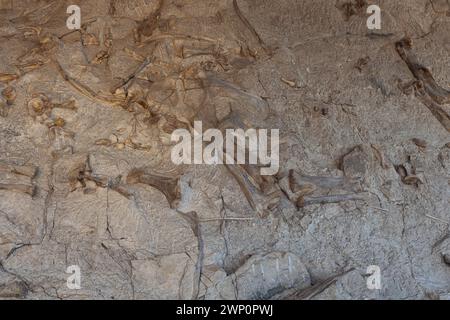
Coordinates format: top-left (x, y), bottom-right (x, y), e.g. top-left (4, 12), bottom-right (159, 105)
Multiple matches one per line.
top-left (0, 0), bottom-right (450, 299)
